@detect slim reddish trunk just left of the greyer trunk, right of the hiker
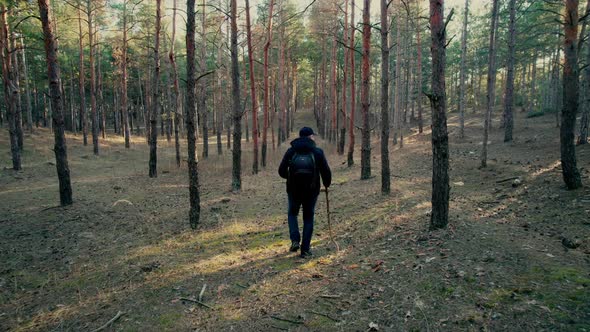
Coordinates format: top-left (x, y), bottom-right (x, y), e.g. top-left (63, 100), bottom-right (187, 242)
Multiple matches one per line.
top-left (361, 0), bottom-right (371, 180)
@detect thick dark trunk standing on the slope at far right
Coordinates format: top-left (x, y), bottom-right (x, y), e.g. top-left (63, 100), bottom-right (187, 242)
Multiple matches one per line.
top-left (559, 0), bottom-right (582, 190)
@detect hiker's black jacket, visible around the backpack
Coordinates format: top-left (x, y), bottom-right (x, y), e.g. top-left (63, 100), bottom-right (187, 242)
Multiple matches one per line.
top-left (279, 137), bottom-right (332, 195)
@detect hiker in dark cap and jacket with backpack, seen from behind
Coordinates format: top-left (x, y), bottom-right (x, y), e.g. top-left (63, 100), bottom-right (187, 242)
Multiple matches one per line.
top-left (279, 127), bottom-right (332, 258)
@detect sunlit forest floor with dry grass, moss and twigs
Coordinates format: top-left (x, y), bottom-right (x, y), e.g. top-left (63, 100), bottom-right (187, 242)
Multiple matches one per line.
top-left (0, 107), bottom-right (590, 331)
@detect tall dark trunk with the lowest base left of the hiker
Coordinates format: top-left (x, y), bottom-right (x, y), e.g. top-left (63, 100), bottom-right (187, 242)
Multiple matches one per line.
top-left (185, 0), bottom-right (205, 229)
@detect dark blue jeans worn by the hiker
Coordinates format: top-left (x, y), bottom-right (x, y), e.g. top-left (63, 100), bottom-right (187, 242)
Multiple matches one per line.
top-left (288, 193), bottom-right (318, 252)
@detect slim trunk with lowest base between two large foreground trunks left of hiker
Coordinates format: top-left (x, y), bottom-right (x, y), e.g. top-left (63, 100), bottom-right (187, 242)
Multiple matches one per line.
top-left (149, 0), bottom-right (162, 178)
